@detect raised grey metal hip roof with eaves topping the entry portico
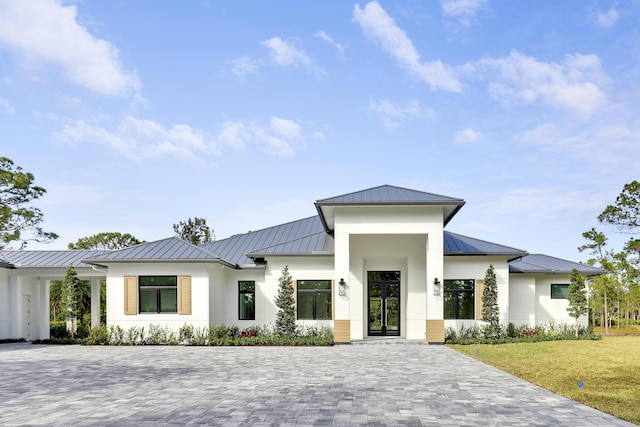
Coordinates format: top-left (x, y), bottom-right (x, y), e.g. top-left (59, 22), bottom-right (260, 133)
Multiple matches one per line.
top-left (315, 185), bottom-right (465, 233)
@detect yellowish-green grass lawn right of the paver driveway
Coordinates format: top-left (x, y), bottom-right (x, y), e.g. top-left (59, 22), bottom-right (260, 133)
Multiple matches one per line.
top-left (449, 335), bottom-right (640, 424)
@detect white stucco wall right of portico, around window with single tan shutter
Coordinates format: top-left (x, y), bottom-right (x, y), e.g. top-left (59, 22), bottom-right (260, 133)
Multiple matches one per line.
top-left (443, 256), bottom-right (510, 330)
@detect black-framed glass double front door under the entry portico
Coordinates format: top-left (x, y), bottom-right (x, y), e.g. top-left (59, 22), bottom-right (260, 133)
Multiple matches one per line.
top-left (367, 271), bottom-right (400, 336)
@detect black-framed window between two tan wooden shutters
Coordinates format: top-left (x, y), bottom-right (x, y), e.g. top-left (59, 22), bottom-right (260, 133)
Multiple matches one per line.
top-left (138, 276), bottom-right (178, 313)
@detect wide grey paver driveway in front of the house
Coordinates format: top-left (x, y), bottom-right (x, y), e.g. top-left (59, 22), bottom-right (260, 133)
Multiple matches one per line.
top-left (0, 343), bottom-right (631, 427)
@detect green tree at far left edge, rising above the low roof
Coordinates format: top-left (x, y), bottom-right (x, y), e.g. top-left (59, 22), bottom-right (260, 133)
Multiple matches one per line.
top-left (0, 157), bottom-right (58, 250)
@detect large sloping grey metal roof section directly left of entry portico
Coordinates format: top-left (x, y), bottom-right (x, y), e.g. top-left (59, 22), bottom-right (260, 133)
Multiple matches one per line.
top-left (201, 216), bottom-right (324, 265)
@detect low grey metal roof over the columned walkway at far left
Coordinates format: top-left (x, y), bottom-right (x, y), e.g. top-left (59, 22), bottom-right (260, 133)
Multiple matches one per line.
top-left (1, 250), bottom-right (109, 268)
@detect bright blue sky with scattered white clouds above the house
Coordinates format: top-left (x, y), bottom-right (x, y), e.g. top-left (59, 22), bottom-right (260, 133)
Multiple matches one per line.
top-left (0, 0), bottom-right (640, 261)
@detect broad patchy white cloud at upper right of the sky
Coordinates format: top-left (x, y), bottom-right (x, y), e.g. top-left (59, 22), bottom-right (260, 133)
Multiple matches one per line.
top-left (461, 52), bottom-right (609, 115)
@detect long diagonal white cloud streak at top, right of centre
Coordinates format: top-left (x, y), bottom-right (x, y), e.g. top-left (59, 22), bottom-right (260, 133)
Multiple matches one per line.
top-left (352, 1), bottom-right (462, 92)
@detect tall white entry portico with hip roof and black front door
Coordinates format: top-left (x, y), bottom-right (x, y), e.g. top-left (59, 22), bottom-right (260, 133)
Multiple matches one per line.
top-left (315, 186), bottom-right (464, 342)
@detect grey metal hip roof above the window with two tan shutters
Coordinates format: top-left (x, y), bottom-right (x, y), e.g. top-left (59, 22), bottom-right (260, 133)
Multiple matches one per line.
top-left (83, 237), bottom-right (230, 264)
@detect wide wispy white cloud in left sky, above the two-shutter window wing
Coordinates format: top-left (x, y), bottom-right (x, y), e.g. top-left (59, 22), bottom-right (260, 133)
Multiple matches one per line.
top-left (54, 116), bottom-right (214, 160)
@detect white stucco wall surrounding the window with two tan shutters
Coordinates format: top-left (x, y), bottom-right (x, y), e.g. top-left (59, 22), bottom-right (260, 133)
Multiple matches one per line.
top-left (107, 262), bottom-right (211, 332)
